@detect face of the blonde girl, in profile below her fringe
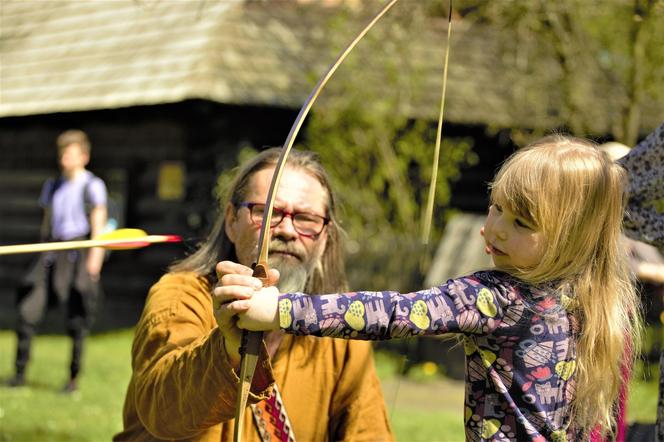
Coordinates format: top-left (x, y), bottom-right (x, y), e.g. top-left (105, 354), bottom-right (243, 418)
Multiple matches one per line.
top-left (480, 204), bottom-right (545, 271)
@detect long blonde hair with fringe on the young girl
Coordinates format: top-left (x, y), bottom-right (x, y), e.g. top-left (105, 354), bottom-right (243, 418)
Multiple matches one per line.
top-left (491, 135), bottom-right (641, 435)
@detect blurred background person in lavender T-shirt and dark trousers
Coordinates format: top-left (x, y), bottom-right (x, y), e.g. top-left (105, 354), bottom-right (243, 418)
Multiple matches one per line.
top-left (9, 130), bottom-right (107, 392)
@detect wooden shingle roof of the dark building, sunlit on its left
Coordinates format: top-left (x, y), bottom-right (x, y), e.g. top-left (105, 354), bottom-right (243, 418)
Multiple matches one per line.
top-left (0, 0), bottom-right (661, 133)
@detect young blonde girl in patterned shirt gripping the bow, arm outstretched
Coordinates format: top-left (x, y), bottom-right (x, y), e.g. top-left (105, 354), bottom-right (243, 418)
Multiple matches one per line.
top-left (214, 136), bottom-right (640, 441)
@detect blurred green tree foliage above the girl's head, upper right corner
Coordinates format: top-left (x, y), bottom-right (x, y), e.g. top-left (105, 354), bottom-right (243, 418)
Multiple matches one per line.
top-left (456, 0), bottom-right (664, 145)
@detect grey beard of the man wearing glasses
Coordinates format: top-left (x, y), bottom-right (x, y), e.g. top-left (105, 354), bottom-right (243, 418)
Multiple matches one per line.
top-left (268, 238), bottom-right (316, 293)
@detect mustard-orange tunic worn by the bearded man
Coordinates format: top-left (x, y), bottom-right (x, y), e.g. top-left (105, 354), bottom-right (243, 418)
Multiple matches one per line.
top-left (114, 273), bottom-right (393, 441)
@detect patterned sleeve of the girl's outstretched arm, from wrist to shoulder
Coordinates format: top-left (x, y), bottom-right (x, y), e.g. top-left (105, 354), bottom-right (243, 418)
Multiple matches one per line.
top-left (278, 277), bottom-right (510, 340)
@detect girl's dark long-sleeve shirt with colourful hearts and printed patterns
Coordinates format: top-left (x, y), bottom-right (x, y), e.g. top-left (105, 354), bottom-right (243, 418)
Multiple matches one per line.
top-left (279, 271), bottom-right (576, 441)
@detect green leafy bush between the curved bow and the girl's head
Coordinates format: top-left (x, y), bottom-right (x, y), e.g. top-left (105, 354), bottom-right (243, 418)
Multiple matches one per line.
top-left (305, 2), bottom-right (477, 288)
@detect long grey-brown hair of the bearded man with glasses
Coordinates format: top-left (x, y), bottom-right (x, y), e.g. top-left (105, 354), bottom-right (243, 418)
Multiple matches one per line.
top-left (170, 148), bottom-right (348, 293)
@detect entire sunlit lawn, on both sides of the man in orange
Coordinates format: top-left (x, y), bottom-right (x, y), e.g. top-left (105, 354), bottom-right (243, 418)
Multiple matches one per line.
top-left (0, 330), bottom-right (657, 442)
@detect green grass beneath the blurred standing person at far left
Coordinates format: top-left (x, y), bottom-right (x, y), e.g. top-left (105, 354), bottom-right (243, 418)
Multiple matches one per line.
top-left (0, 331), bottom-right (132, 442)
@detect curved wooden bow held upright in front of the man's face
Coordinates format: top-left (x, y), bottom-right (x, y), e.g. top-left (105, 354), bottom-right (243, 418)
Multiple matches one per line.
top-left (233, 0), bottom-right (398, 442)
